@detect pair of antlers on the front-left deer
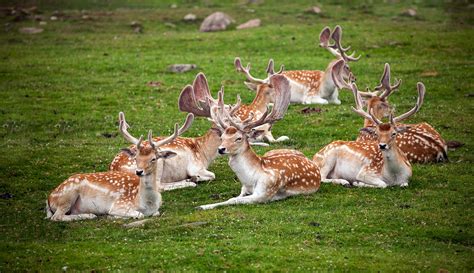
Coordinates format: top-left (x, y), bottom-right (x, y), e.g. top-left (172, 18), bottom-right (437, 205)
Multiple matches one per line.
top-left (119, 112), bottom-right (194, 149)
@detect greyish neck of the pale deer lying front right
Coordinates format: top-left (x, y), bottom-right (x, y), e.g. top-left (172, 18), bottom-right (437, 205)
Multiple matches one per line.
top-left (382, 143), bottom-right (411, 184)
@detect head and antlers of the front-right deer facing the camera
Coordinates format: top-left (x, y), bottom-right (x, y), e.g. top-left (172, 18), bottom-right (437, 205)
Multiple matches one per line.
top-left (350, 82), bottom-right (425, 151)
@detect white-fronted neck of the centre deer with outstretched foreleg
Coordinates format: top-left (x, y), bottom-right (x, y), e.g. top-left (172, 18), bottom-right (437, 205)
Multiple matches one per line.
top-left (229, 142), bottom-right (262, 186)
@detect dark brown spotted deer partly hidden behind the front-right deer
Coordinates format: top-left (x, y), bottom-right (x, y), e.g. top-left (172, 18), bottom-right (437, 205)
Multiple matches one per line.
top-left (335, 61), bottom-right (448, 163)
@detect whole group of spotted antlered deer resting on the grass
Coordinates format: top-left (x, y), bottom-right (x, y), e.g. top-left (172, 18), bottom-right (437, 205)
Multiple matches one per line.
top-left (46, 26), bottom-right (447, 221)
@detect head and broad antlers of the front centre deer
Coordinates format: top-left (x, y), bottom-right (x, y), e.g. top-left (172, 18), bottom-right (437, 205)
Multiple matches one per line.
top-left (211, 75), bottom-right (291, 155)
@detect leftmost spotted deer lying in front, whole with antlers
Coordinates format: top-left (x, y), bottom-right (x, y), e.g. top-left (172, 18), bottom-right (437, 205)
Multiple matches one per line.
top-left (46, 113), bottom-right (192, 221)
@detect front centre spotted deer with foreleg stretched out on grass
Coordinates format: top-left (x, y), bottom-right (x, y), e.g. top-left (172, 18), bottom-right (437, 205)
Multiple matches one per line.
top-left (198, 75), bottom-right (320, 210)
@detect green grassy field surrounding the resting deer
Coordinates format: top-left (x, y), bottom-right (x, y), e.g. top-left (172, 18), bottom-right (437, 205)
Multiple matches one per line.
top-left (0, 0), bottom-right (474, 272)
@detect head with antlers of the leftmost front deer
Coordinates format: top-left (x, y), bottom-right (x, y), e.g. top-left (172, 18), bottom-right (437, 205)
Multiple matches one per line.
top-left (119, 112), bottom-right (194, 176)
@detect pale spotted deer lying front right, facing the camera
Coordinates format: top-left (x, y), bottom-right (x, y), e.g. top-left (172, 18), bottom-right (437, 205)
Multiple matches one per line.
top-left (313, 82), bottom-right (425, 188)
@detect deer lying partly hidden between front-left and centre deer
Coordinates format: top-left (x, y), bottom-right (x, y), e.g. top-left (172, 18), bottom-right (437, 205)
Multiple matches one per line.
top-left (109, 74), bottom-right (221, 191)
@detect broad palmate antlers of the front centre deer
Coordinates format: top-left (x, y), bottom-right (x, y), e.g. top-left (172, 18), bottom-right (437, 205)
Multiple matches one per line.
top-left (211, 75), bottom-right (291, 133)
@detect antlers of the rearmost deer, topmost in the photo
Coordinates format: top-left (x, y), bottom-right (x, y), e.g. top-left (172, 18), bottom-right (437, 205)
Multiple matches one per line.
top-left (319, 25), bottom-right (361, 62)
